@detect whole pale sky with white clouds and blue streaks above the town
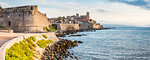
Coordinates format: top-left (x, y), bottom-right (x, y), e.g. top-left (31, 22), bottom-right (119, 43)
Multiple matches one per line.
top-left (0, 0), bottom-right (150, 27)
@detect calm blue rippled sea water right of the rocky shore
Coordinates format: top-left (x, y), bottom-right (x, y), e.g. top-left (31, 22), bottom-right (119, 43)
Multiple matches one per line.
top-left (60, 27), bottom-right (150, 60)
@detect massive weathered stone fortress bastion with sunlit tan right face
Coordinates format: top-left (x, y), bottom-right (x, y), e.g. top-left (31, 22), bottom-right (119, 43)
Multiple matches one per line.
top-left (0, 5), bottom-right (50, 32)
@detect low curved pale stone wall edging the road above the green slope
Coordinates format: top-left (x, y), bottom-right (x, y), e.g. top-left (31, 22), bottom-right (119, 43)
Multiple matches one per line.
top-left (0, 32), bottom-right (59, 60)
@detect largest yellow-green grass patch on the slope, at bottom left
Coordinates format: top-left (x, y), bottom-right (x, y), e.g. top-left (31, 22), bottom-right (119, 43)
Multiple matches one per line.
top-left (5, 40), bottom-right (37, 60)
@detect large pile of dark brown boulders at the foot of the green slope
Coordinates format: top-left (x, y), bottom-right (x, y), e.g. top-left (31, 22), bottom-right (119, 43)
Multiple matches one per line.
top-left (41, 39), bottom-right (83, 60)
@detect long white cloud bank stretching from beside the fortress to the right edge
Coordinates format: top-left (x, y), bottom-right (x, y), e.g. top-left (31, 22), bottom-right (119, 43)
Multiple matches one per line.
top-left (36, 2), bottom-right (150, 26)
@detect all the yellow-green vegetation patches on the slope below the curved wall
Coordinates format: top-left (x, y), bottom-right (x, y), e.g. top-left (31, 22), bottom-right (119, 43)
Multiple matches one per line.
top-left (5, 35), bottom-right (53, 60)
